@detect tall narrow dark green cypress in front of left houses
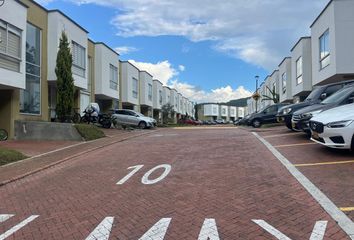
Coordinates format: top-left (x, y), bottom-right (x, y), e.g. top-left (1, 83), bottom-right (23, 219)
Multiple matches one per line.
top-left (55, 31), bottom-right (75, 122)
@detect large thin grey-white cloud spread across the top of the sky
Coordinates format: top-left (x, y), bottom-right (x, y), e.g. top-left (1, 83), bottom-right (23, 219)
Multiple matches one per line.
top-left (65, 0), bottom-right (328, 70)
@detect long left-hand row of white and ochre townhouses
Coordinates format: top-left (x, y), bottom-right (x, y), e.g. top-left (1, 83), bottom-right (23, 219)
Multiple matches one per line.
top-left (0, 0), bottom-right (194, 137)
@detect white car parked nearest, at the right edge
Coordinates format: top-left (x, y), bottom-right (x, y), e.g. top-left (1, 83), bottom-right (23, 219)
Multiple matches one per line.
top-left (310, 104), bottom-right (354, 151)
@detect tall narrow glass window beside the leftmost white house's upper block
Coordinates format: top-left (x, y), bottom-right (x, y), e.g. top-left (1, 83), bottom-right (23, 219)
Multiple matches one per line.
top-left (20, 23), bottom-right (41, 114)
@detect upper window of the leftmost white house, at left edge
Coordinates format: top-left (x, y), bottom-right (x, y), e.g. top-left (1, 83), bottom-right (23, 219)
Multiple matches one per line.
top-left (0, 20), bottom-right (22, 72)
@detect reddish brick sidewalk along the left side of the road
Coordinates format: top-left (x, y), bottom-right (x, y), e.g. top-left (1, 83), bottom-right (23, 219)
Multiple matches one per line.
top-left (0, 129), bottom-right (156, 186)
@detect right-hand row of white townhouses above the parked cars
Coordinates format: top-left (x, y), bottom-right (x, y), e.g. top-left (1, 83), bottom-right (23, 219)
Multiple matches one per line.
top-left (247, 0), bottom-right (354, 113)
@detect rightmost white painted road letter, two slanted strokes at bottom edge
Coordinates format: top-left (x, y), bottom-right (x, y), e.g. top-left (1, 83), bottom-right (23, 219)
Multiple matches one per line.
top-left (252, 219), bottom-right (327, 240)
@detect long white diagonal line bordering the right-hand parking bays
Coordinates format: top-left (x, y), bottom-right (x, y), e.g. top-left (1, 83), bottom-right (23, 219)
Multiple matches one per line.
top-left (253, 132), bottom-right (354, 240)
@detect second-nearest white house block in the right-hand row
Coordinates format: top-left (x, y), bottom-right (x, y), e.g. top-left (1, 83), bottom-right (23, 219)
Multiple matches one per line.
top-left (291, 37), bottom-right (312, 102)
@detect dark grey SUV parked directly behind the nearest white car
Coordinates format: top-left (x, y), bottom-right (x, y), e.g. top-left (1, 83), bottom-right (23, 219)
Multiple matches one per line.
top-left (291, 85), bottom-right (354, 136)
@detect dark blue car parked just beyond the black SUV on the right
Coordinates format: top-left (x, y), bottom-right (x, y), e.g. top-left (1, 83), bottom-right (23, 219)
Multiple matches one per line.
top-left (248, 103), bottom-right (286, 128)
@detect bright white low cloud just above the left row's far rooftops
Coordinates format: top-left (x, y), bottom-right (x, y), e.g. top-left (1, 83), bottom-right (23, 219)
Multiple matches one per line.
top-left (129, 60), bottom-right (252, 103)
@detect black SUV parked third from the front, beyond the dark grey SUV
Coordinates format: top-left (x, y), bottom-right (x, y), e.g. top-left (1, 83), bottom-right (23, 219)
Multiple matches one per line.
top-left (277, 80), bottom-right (354, 130)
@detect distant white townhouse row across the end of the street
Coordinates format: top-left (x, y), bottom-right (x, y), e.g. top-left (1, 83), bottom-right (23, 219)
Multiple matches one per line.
top-left (196, 103), bottom-right (247, 122)
